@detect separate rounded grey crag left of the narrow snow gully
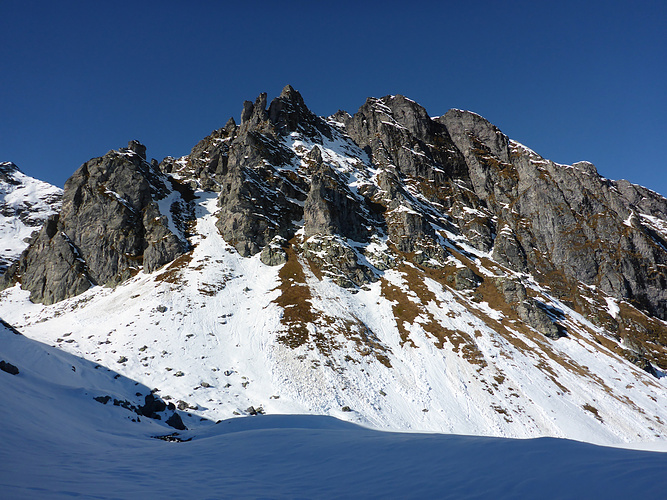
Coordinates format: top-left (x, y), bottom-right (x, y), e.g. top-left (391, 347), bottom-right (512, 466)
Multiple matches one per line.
top-left (2, 141), bottom-right (188, 304)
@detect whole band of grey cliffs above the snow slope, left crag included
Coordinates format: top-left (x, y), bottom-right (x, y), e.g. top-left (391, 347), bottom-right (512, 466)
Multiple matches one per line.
top-left (3, 86), bottom-right (667, 371)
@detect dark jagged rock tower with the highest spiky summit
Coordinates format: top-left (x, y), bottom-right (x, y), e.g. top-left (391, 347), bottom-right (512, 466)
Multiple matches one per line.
top-left (216, 88), bottom-right (320, 256)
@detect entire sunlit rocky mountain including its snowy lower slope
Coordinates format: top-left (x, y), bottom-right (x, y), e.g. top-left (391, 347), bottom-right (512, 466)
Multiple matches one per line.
top-left (0, 86), bottom-right (667, 442)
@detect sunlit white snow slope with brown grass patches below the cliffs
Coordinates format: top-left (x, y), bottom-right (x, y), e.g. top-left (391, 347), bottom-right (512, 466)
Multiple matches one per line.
top-left (0, 192), bottom-right (667, 444)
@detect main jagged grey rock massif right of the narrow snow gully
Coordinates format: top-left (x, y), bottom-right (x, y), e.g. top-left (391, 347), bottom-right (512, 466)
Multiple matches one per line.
top-left (163, 86), bottom-right (667, 326)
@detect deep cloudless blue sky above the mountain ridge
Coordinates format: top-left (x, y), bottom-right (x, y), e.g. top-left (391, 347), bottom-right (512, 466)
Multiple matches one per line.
top-left (0, 0), bottom-right (667, 195)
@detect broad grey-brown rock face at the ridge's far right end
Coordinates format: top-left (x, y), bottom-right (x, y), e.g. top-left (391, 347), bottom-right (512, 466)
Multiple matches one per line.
top-left (439, 110), bottom-right (667, 319)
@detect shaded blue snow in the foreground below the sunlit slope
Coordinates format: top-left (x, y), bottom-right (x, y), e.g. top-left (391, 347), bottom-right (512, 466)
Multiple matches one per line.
top-left (0, 326), bottom-right (667, 499)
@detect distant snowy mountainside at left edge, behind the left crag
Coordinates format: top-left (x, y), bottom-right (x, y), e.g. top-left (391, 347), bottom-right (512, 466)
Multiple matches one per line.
top-left (0, 162), bottom-right (63, 273)
